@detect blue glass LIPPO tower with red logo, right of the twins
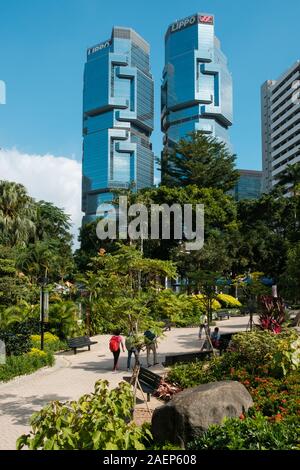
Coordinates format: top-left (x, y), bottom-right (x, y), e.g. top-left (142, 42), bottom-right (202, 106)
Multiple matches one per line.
top-left (161, 13), bottom-right (232, 152)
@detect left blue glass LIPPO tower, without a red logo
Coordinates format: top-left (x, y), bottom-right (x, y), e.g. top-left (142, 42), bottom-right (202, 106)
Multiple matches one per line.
top-left (82, 27), bottom-right (154, 222)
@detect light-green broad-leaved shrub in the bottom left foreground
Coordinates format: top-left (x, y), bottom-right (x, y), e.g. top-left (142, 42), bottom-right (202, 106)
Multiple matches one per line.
top-left (17, 381), bottom-right (152, 450)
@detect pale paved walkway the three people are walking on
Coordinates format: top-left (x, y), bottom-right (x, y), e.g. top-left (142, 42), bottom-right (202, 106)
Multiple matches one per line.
top-left (0, 317), bottom-right (249, 450)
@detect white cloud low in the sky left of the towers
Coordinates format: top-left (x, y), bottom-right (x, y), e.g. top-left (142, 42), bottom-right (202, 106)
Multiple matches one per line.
top-left (0, 148), bottom-right (82, 244)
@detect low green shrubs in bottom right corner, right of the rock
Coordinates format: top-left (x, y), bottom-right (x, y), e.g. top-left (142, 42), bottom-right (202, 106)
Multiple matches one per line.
top-left (188, 413), bottom-right (300, 450)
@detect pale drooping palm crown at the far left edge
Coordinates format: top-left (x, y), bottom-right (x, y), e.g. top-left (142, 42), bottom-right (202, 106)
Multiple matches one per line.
top-left (0, 181), bottom-right (36, 246)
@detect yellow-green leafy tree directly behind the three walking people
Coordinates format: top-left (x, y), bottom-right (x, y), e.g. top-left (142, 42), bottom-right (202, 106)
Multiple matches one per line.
top-left (80, 245), bottom-right (176, 333)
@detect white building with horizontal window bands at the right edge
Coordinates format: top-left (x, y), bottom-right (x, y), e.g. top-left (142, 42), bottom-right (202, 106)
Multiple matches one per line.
top-left (261, 61), bottom-right (300, 193)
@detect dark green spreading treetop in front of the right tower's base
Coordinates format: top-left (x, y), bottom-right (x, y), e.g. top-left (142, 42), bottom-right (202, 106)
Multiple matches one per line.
top-left (161, 131), bottom-right (239, 192)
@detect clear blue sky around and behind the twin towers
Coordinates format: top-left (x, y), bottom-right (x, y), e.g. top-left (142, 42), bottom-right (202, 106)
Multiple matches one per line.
top-left (0, 0), bottom-right (300, 173)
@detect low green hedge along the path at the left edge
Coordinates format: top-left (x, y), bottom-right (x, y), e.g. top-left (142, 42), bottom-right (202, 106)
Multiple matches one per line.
top-left (0, 349), bottom-right (54, 382)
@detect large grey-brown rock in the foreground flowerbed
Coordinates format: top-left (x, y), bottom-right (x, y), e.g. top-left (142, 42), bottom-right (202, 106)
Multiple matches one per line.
top-left (152, 380), bottom-right (253, 445)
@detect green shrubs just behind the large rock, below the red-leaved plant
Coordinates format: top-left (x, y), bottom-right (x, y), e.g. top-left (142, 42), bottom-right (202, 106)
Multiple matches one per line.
top-left (168, 331), bottom-right (299, 388)
